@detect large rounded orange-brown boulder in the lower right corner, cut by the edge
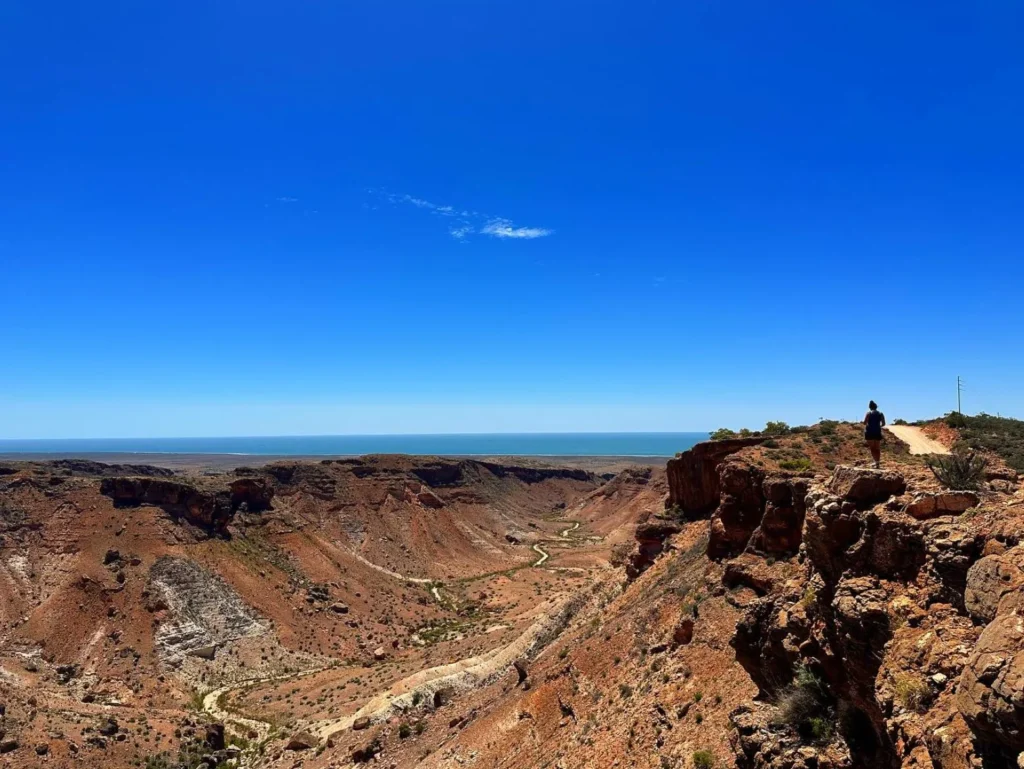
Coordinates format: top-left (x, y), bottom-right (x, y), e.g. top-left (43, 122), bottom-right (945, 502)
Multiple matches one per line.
top-left (956, 613), bottom-right (1024, 751)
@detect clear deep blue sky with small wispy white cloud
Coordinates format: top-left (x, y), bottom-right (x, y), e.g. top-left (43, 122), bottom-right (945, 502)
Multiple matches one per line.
top-left (0, 0), bottom-right (1024, 438)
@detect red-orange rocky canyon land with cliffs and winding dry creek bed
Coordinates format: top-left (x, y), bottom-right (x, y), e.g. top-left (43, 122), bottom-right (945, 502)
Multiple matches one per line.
top-left (0, 423), bottom-right (1024, 769)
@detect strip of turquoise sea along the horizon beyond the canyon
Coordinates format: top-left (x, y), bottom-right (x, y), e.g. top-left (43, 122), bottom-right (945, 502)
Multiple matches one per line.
top-left (0, 432), bottom-right (708, 457)
